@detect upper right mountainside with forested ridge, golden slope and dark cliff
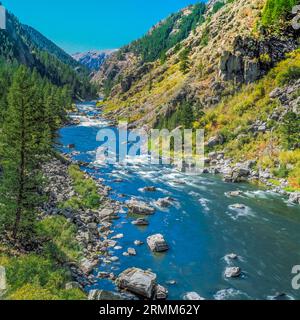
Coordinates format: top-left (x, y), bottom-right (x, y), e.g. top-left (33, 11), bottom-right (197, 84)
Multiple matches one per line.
top-left (94, 0), bottom-right (298, 126)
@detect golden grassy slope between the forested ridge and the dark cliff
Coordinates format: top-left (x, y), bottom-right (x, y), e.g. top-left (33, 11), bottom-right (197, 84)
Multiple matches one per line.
top-left (102, 0), bottom-right (266, 125)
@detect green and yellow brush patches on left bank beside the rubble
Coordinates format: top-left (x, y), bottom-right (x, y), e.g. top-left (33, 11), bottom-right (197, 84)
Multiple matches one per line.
top-left (0, 165), bottom-right (101, 300)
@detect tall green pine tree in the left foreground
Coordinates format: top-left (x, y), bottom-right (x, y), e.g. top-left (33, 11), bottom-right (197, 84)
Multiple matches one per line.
top-left (0, 66), bottom-right (49, 239)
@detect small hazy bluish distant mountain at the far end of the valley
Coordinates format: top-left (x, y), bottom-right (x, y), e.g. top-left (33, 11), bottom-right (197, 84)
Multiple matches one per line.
top-left (72, 50), bottom-right (116, 71)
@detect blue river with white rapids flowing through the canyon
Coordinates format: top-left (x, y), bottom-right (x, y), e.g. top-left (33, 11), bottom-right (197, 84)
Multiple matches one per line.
top-left (60, 103), bottom-right (300, 299)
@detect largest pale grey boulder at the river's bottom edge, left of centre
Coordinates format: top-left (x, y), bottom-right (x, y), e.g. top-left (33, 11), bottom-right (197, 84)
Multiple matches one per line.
top-left (116, 268), bottom-right (157, 299)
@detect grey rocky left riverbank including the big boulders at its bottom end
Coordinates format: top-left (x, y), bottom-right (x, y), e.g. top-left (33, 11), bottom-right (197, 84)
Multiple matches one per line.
top-left (40, 155), bottom-right (168, 300)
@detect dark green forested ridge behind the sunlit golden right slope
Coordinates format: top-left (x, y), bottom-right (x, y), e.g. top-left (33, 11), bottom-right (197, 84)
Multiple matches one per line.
top-left (94, 3), bottom-right (206, 97)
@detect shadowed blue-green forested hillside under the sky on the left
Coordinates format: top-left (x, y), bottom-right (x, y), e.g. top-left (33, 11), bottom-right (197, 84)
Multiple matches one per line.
top-left (0, 13), bottom-right (95, 98)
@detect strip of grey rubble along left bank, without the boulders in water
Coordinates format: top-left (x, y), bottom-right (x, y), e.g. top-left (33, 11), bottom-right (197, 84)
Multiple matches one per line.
top-left (40, 158), bottom-right (120, 288)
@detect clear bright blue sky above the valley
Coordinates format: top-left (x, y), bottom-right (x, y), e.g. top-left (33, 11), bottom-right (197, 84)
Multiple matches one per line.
top-left (2, 0), bottom-right (205, 53)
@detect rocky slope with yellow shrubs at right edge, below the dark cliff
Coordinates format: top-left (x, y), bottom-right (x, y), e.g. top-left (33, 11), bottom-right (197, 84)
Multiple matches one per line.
top-left (202, 50), bottom-right (300, 191)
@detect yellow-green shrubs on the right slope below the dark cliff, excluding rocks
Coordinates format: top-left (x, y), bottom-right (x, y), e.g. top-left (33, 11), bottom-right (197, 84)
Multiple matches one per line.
top-left (195, 51), bottom-right (300, 190)
